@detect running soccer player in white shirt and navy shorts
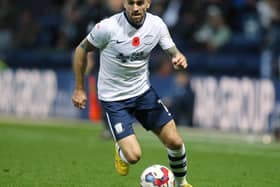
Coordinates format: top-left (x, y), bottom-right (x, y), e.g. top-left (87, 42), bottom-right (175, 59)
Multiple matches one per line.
top-left (72, 0), bottom-right (192, 187)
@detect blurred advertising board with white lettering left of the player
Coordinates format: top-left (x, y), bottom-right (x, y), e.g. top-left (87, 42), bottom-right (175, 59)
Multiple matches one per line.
top-left (0, 69), bottom-right (82, 118)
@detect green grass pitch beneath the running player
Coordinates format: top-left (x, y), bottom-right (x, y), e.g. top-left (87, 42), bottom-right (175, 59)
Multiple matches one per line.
top-left (0, 118), bottom-right (280, 187)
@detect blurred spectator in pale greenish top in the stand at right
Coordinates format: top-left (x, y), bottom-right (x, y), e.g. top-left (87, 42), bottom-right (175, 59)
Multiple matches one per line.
top-left (194, 5), bottom-right (231, 52)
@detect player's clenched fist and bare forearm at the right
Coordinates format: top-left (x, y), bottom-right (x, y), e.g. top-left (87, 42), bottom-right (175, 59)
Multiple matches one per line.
top-left (165, 46), bottom-right (188, 69)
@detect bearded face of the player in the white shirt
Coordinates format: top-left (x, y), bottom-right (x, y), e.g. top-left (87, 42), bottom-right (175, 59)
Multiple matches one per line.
top-left (124, 0), bottom-right (151, 25)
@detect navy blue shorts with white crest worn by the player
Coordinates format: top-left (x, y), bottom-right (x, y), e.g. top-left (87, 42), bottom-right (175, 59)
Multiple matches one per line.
top-left (101, 88), bottom-right (173, 141)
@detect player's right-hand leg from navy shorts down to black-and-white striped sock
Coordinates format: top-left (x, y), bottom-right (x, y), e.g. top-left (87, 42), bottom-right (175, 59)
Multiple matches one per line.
top-left (135, 88), bottom-right (191, 187)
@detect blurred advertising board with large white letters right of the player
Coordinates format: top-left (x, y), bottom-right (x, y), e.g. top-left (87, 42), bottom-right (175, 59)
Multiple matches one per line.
top-left (191, 77), bottom-right (277, 133)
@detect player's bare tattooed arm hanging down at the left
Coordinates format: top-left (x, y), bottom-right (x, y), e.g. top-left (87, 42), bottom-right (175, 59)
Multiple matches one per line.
top-left (72, 39), bottom-right (94, 109)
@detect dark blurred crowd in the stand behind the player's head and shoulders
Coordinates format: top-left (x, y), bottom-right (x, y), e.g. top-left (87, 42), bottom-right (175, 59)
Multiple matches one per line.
top-left (0, 0), bottom-right (280, 52)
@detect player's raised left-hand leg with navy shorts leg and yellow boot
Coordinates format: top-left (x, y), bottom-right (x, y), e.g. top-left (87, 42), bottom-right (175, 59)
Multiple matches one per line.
top-left (102, 102), bottom-right (141, 176)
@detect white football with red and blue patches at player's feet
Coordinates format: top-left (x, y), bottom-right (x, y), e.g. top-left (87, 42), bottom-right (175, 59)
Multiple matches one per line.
top-left (140, 164), bottom-right (175, 187)
